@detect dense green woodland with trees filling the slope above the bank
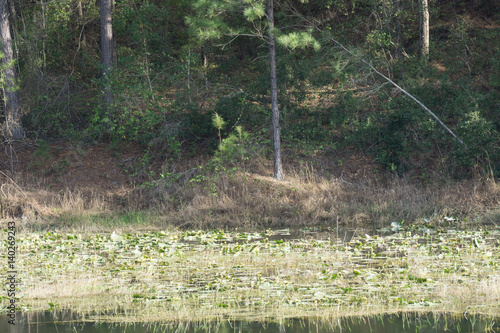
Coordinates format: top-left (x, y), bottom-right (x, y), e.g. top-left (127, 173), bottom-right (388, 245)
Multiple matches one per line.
top-left (0, 0), bottom-right (500, 227)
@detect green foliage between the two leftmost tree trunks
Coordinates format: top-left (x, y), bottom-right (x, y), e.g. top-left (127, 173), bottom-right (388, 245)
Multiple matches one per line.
top-left (16, 0), bottom-right (99, 139)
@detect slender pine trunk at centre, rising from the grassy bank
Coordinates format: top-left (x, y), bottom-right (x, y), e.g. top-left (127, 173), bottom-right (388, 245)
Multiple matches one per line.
top-left (267, 0), bottom-right (283, 180)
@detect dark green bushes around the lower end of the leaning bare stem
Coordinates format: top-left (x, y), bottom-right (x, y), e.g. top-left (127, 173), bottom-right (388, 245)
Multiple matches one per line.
top-left (330, 76), bottom-right (500, 175)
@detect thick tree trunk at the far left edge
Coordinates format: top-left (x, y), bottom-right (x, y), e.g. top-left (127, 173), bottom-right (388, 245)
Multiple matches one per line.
top-left (0, 0), bottom-right (24, 140)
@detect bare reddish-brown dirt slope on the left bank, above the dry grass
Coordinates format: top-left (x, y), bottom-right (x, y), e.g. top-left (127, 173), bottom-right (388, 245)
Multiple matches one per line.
top-left (0, 142), bottom-right (141, 192)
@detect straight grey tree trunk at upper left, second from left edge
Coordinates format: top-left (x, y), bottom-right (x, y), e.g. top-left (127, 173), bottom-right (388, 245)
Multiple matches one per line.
top-left (100, 0), bottom-right (113, 113)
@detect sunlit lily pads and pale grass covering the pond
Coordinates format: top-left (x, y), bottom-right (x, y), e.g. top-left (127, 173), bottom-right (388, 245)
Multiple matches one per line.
top-left (0, 226), bottom-right (500, 321)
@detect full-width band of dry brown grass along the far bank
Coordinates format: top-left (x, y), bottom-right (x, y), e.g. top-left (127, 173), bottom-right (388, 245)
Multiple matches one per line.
top-left (0, 160), bottom-right (500, 228)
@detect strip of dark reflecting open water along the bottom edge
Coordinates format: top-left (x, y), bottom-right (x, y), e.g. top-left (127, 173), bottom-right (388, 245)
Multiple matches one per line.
top-left (0, 311), bottom-right (500, 333)
